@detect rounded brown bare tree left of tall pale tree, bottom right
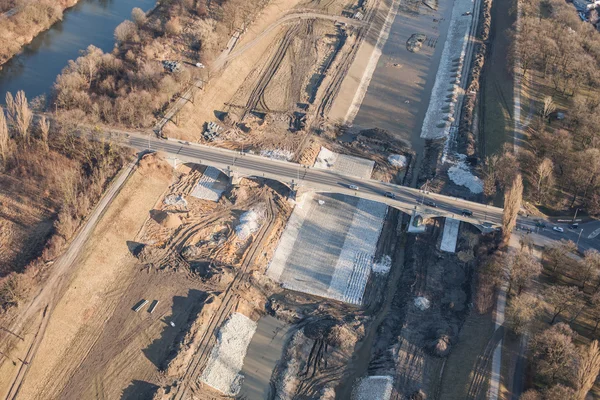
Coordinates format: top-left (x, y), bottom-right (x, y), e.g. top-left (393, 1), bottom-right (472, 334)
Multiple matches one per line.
top-left (531, 322), bottom-right (577, 384)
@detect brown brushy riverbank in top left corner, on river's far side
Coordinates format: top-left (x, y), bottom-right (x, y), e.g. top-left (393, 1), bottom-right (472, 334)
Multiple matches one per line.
top-left (0, 0), bottom-right (78, 69)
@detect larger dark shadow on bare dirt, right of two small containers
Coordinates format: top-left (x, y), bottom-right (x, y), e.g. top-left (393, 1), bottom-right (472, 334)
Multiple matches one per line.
top-left (142, 289), bottom-right (208, 370)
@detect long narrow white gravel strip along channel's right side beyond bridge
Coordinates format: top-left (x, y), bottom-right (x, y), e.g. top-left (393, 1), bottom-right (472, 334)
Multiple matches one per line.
top-left (421, 0), bottom-right (474, 139)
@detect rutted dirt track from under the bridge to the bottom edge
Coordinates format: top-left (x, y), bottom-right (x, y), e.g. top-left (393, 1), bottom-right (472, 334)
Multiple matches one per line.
top-left (174, 198), bottom-right (276, 400)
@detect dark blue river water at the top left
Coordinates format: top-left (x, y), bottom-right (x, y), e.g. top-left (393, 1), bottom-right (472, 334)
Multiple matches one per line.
top-left (0, 0), bottom-right (156, 103)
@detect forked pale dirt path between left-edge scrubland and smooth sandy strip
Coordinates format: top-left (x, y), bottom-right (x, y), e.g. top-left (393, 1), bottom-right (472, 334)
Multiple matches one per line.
top-left (0, 163), bottom-right (135, 399)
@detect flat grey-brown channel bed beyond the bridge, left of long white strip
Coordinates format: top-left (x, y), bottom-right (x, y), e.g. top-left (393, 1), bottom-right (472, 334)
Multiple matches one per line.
top-left (346, 1), bottom-right (449, 150)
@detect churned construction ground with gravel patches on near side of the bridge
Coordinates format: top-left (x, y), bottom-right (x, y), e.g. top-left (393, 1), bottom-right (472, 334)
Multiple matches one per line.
top-left (1, 149), bottom-right (490, 400)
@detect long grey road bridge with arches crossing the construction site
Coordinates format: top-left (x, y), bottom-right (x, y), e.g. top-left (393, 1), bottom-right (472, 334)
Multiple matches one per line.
top-left (105, 132), bottom-right (502, 229)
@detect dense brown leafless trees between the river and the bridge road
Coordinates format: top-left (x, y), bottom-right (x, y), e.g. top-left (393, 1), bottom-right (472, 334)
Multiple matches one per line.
top-left (52, 0), bottom-right (265, 128)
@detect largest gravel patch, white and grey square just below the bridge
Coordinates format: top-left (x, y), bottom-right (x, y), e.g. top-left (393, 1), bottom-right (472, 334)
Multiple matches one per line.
top-left (267, 195), bottom-right (387, 305)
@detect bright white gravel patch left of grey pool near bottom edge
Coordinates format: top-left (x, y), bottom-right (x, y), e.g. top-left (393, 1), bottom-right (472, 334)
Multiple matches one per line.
top-left (200, 313), bottom-right (257, 396)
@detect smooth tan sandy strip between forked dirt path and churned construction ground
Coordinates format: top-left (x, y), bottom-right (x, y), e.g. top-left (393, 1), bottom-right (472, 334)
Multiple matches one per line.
top-left (14, 156), bottom-right (171, 399)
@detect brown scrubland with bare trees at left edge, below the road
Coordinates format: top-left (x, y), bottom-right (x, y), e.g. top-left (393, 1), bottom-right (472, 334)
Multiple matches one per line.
top-left (0, 91), bottom-right (127, 312)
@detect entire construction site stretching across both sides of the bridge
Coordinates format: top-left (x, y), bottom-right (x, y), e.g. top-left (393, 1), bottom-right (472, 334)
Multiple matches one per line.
top-left (0, 0), bottom-right (497, 400)
